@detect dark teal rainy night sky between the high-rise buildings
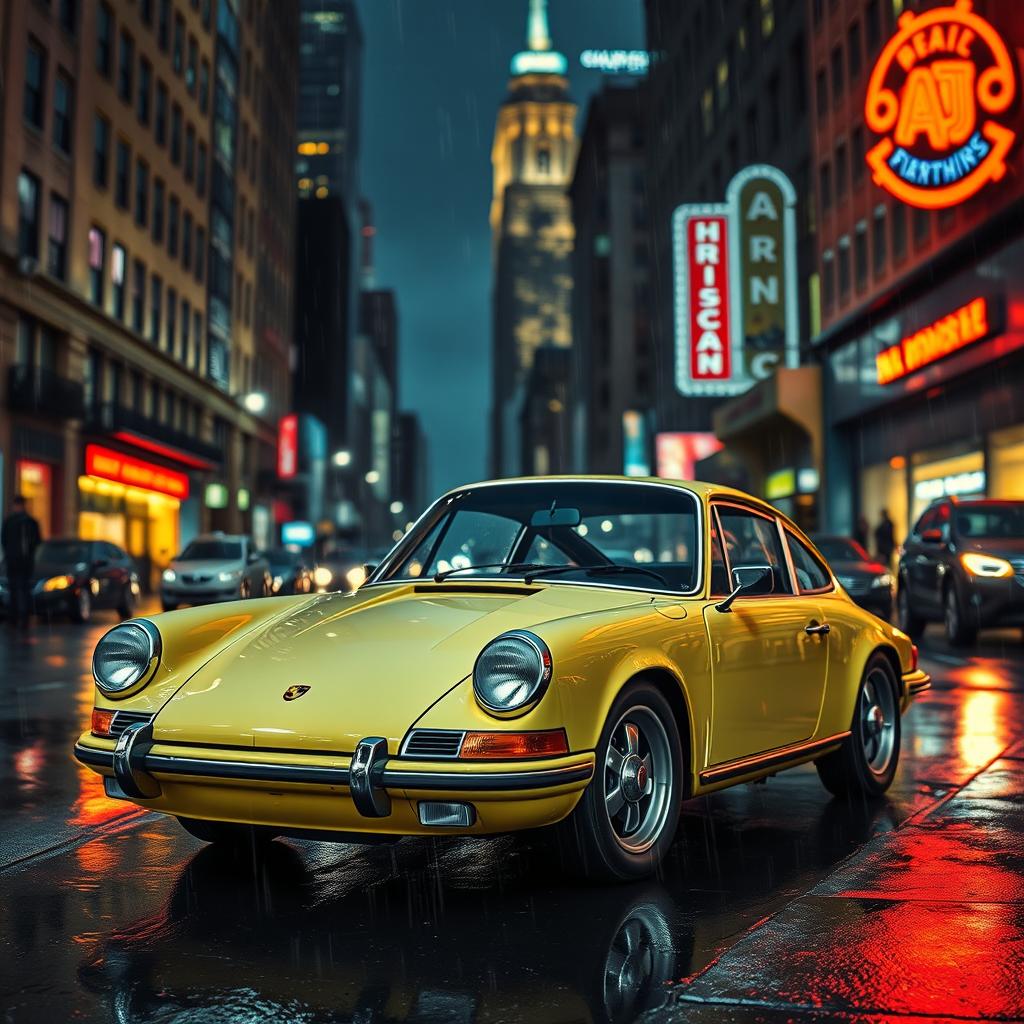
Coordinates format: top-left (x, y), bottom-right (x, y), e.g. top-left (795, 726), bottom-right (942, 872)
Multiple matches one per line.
top-left (359, 0), bottom-right (643, 493)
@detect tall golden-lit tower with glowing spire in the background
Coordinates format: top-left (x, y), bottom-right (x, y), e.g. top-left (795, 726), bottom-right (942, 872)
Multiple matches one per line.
top-left (490, 0), bottom-right (577, 476)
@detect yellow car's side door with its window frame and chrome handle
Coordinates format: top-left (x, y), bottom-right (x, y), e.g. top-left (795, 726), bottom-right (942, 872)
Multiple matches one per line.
top-left (703, 502), bottom-right (830, 765)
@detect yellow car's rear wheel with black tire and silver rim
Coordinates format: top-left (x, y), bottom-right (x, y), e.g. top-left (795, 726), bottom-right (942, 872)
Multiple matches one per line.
top-left (814, 653), bottom-right (902, 798)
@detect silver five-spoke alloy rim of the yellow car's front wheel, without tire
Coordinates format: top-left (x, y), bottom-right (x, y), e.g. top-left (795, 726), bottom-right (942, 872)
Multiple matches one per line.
top-left (604, 706), bottom-right (673, 853)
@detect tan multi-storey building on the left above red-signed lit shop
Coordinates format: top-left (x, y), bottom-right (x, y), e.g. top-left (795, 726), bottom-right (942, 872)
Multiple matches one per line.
top-left (0, 0), bottom-right (298, 583)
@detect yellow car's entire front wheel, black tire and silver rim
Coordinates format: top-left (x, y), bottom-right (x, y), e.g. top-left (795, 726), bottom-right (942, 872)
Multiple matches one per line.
top-left (554, 681), bottom-right (684, 882)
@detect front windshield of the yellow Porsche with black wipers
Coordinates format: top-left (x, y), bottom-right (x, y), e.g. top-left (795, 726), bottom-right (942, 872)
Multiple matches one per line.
top-left (374, 481), bottom-right (699, 591)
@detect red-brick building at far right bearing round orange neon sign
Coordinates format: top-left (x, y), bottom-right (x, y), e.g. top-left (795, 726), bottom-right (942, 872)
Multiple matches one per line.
top-left (809, 0), bottom-right (1024, 540)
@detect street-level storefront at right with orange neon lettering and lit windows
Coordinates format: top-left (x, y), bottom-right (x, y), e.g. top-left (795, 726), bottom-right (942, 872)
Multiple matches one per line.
top-left (824, 233), bottom-right (1024, 542)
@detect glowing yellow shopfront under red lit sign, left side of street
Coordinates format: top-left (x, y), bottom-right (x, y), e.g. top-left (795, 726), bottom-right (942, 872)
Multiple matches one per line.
top-left (78, 443), bottom-right (197, 589)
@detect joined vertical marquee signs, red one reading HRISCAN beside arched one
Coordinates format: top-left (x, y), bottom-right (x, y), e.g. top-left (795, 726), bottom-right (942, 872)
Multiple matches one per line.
top-left (672, 164), bottom-right (800, 396)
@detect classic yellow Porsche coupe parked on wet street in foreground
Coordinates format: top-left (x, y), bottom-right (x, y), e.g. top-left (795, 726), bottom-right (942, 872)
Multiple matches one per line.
top-left (75, 477), bottom-right (929, 879)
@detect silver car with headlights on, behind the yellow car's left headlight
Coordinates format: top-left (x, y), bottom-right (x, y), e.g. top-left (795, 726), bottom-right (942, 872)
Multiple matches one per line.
top-left (160, 534), bottom-right (271, 611)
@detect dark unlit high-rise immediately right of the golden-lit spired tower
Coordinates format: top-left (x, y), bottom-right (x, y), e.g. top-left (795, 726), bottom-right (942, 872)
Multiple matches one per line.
top-left (569, 83), bottom-right (654, 473)
